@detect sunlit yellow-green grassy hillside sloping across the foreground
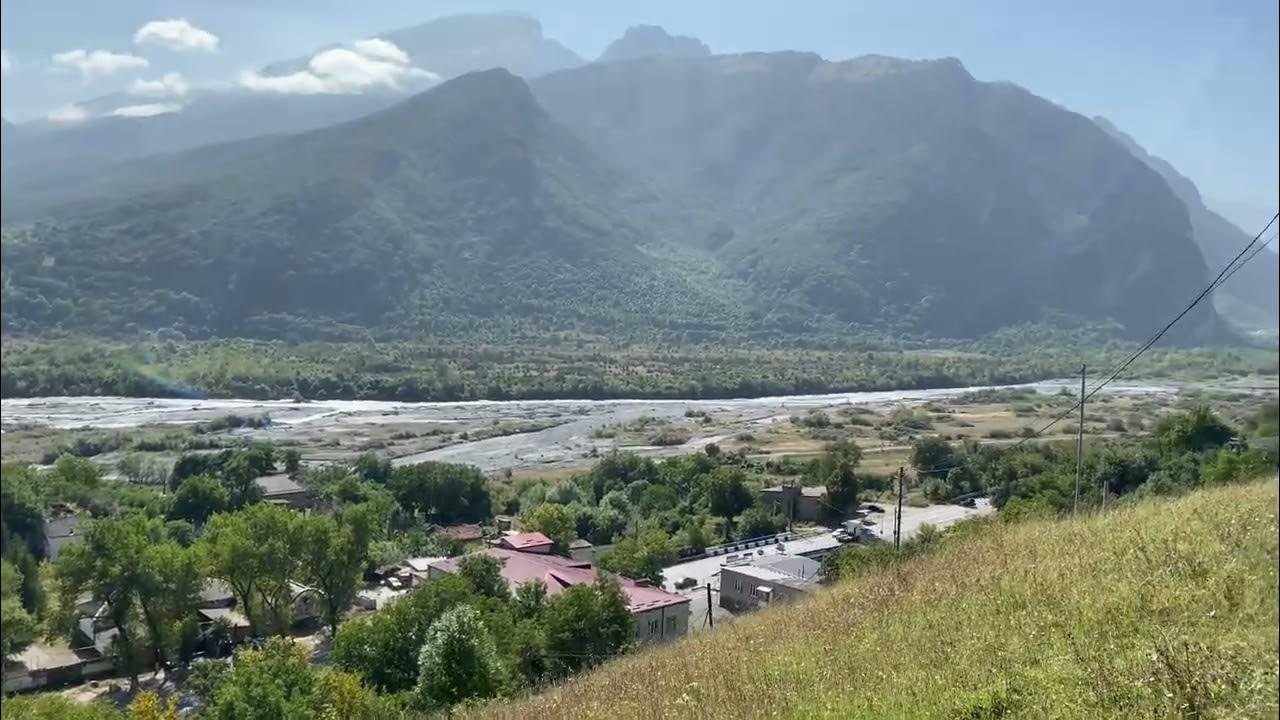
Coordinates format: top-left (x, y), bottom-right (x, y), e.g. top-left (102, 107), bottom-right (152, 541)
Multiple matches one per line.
top-left (477, 480), bottom-right (1280, 720)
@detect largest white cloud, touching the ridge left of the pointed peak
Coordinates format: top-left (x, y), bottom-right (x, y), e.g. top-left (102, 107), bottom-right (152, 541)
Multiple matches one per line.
top-left (239, 38), bottom-right (440, 95)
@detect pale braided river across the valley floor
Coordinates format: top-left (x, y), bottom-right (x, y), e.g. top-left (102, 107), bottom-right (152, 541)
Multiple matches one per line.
top-left (0, 379), bottom-right (1176, 471)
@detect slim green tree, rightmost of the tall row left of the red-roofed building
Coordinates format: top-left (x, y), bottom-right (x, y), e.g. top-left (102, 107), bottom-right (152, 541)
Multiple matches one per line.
top-left (298, 506), bottom-right (372, 633)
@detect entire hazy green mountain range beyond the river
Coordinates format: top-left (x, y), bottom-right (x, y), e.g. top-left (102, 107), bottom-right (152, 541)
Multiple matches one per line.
top-left (3, 16), bottom-right (1259, 341)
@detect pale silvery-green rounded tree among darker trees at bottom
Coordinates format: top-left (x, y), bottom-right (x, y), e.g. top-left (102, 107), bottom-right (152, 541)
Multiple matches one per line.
top-left (417, 605), bottom-right (503, 708)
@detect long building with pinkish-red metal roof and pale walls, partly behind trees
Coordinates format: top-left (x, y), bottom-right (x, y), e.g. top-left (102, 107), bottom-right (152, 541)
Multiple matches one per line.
top-left (431, 545), bottom-right (689, 642)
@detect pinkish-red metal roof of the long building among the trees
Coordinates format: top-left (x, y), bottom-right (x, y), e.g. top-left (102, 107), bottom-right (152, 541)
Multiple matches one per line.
top-left (431, 548), bottom-right (689, 612)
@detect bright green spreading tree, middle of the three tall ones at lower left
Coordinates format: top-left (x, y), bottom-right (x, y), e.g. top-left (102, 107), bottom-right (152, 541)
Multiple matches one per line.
top-left (197, 503), bottom-right (303, 634)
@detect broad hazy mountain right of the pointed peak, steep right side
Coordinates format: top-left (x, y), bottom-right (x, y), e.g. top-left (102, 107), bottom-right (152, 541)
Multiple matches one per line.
top-left (532, 53), bottom-right (1216, 338)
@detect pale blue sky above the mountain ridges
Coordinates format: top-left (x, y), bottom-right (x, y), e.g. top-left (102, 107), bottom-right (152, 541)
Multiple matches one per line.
top-left (0, 0), bottom-right (1280, 219)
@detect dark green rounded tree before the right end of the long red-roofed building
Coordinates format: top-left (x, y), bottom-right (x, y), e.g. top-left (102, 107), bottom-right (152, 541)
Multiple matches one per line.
top-left (544, 573), bottom-right (635, 676)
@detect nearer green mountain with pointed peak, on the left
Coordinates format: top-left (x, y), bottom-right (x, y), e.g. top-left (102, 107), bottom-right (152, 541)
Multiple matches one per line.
top-left (4, 70), bottom-right (735, 337)
